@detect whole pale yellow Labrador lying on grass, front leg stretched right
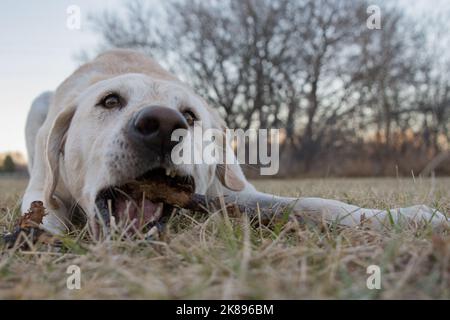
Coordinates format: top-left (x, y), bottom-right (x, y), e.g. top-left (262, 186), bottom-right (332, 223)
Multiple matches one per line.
top-left (22, 49), bottom-right (449, 234)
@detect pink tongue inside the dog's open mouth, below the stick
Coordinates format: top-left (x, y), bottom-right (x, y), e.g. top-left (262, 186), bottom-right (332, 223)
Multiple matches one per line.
top-left (116, 199), bottom-right (162, 229)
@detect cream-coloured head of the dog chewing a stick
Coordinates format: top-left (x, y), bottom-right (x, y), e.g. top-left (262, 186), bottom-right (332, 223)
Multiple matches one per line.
top-left (46, 74), bottom-right (245, 229)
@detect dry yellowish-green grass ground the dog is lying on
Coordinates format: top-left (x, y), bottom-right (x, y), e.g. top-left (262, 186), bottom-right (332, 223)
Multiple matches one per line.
top-left (0, 178), bottom-right (450, 299)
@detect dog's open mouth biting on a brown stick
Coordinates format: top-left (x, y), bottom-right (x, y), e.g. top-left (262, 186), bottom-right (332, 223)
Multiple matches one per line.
top-left (95, 168), bottom-right (195, 231)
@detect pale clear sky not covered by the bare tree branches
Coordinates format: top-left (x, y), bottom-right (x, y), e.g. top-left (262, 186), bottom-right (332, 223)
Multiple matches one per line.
top-left (0, 0), bottom-right (450, 159)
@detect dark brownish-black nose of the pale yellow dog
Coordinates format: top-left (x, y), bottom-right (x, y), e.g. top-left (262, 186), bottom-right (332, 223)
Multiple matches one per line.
top-left (128, 106), bottom-right (188, 153)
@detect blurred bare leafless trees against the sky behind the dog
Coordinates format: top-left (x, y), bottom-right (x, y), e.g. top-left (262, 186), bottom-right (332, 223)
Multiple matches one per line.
top-left (91, 0), bottom-right (450, 175)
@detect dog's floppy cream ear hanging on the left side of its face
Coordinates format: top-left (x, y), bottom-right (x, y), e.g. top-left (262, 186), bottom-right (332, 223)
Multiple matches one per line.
top-left (44, 105), bottom-right (76, 209)
